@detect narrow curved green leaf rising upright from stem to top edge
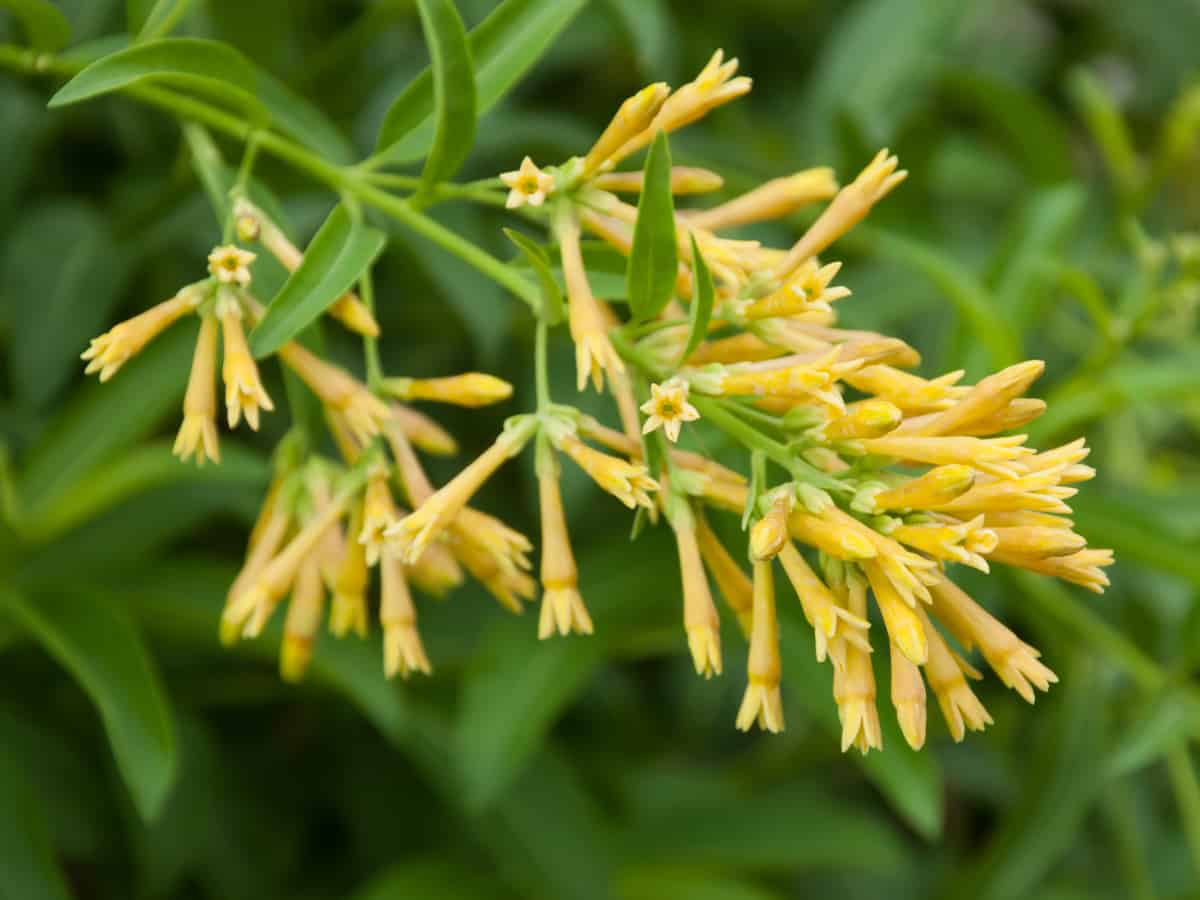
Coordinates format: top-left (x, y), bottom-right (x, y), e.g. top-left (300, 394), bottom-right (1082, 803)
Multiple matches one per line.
top-left (416, 0), bottom-right (475, 190)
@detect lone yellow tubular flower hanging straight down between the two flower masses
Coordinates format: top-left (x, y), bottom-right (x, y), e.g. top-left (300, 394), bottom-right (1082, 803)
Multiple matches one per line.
top-left (538, 458), bottom-right (592, 640)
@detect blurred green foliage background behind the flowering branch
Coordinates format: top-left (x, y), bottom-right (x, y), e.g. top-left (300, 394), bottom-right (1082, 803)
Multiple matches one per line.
top-left (0, 0), bottom-right (1200, 900)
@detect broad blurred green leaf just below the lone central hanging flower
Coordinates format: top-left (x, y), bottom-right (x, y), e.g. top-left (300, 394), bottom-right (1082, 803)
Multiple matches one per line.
top-left (455, 622), bottom-right (600, 810)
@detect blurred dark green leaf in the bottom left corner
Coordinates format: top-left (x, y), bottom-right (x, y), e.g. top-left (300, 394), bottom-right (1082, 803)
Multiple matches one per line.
top-left (0, 746), bottom-right (71, 900)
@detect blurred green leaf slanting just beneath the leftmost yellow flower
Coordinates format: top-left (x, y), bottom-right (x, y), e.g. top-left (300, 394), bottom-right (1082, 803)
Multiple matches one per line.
top-left (18, 322), bottom-right (198, 521)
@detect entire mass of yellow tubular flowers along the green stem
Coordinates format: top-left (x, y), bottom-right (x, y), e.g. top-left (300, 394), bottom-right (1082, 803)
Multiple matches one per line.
top-left (84, 52), bottom-right (1112, 752)
